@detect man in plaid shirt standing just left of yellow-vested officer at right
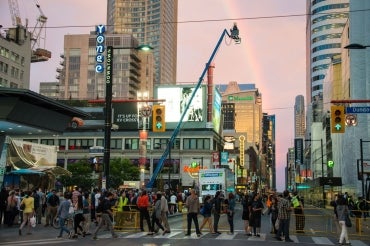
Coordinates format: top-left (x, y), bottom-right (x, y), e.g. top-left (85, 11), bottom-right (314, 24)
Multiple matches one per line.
top-left (276, 190), bottom-right (293, 242)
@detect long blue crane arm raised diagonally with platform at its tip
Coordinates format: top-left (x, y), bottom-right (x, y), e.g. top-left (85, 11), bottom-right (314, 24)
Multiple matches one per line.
top-left (146, 24), bottom-right (240, 188)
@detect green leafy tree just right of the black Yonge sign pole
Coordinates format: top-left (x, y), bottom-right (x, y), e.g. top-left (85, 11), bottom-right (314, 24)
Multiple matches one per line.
top-left (109, 158), bottom-right (140, 188)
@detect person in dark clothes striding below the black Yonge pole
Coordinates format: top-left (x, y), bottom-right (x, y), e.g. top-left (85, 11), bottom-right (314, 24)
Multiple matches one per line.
top-left (93, 192), bottom-right (118, 240)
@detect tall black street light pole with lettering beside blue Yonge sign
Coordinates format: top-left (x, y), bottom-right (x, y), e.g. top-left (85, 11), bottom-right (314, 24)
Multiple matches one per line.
top-left (102, 45), bottom-right (153, 189)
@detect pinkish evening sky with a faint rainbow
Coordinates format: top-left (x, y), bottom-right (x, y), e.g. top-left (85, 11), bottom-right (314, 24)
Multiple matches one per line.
top-left (0, 0), bottom-right (306, 191)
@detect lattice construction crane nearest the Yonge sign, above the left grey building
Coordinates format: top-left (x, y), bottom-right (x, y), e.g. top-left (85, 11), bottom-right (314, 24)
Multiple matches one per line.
top-left (31, 3), bottom-right (51, 62)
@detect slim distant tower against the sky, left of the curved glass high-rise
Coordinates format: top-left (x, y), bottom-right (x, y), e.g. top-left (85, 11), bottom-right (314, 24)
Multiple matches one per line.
top-left (294, 95), bottom-right (306, 138)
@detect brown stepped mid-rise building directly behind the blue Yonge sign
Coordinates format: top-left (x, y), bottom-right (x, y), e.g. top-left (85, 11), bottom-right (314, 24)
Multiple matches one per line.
top-left (57, 33), bottom-right (153, 99)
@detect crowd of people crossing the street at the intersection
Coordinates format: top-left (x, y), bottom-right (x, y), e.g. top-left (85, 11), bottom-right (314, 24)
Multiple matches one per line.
top-left (0, 187), bottom-right (368, 245)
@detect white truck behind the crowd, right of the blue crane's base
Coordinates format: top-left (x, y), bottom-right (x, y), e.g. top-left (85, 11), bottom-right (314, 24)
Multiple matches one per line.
top-left (199, 168), bottom-right (235, 197)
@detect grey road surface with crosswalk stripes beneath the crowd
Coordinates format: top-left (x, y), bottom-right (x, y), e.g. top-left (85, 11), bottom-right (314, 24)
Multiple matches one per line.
top-left (0, 205), bottom-right (370, 246)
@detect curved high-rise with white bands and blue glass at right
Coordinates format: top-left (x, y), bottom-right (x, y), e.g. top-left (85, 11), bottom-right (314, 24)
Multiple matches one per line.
top-left (306, 0), bottom-right (349, 122)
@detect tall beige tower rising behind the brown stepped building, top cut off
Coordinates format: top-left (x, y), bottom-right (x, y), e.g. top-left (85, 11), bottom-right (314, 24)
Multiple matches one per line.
top-left (107, 0), bottom-right (178, 85)
